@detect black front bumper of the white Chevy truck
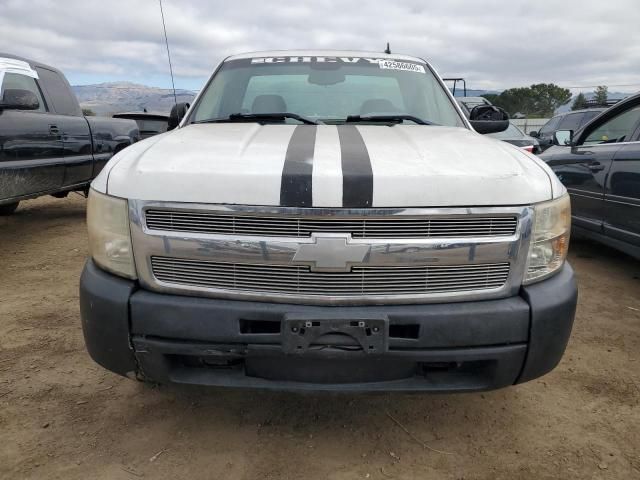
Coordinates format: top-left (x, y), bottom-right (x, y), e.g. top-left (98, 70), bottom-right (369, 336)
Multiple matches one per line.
top-left (80, 260), bottom-right (577, 391)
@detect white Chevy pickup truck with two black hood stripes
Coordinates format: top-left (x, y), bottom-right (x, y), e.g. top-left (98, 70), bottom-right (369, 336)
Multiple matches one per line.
top-left (80, 51), bottom-right (577, 391)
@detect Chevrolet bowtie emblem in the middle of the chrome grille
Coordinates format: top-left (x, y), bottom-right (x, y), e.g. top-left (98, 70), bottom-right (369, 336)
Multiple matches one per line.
top-left (293, 234), bottom-right (371, 272)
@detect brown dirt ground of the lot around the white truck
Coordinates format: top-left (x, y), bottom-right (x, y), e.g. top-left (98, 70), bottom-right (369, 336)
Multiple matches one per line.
top-left (0, 195), bottom-right (640, 480)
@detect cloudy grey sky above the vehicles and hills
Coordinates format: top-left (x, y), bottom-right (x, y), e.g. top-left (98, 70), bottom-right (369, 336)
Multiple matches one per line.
top-left (0, 0), bottom-right (640, 92)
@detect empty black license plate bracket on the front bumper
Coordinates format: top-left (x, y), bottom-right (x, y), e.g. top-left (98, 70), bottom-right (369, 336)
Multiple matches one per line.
top-left (282, 317), bottom-right (389, 354)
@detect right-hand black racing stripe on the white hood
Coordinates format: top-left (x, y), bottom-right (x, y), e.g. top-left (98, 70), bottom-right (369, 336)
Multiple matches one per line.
top-left (338, 125), bottom-right (373, 208)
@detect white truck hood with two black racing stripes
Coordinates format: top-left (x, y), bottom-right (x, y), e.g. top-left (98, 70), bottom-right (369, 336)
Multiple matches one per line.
top-left (102, 123), bottom-right (561, 208)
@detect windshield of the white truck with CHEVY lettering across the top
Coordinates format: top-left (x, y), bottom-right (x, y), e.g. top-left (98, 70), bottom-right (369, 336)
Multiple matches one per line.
top-left (190, 57), bottom-right (464, 126)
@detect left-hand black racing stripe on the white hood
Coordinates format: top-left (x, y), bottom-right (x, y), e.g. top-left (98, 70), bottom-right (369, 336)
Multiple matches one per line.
top-left (280, 125), bottom-right (317, 207)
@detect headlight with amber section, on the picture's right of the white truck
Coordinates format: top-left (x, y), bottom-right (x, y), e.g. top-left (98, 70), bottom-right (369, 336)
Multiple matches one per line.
top-left (524, 194), bottom-right (571, 284)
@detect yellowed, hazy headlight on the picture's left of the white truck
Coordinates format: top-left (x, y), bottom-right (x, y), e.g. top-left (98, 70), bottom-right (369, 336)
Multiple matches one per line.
top-left (87, 189), bottom-right (136, 279)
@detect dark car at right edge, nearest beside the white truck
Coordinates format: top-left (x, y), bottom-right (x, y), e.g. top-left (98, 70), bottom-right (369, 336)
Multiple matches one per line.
top-left (540, 94), bottom-right (640, 258)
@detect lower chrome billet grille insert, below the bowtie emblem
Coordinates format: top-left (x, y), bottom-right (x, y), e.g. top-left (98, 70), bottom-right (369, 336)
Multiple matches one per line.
top-left (151, 256), bottom-right (509, 297)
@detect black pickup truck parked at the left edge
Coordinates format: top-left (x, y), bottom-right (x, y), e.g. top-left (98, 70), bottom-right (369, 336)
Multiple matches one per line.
top-left (0, 53), bottom-right (139, 215)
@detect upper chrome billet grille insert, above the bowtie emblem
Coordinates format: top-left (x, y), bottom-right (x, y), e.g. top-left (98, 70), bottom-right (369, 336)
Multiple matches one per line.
top-left (145, 209), bottom-right (518, 238)
